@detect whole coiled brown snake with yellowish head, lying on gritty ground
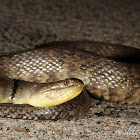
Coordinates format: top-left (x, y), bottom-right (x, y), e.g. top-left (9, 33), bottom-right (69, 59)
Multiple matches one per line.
top-left (0, 41), bottom-right (140, 120)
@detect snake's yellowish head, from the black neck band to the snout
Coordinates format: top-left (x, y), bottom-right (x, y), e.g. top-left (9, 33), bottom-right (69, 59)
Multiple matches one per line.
top-left (13, 78), bottom-right (84, 107)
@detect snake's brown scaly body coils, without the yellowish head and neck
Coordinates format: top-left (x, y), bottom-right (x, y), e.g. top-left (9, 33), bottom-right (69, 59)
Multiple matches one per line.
top-left (0, 41), bottom-right (140, 120)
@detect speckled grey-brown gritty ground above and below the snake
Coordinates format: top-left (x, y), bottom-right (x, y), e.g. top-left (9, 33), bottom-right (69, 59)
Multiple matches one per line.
top-left (0, 0), bottom-right (140, 140)
